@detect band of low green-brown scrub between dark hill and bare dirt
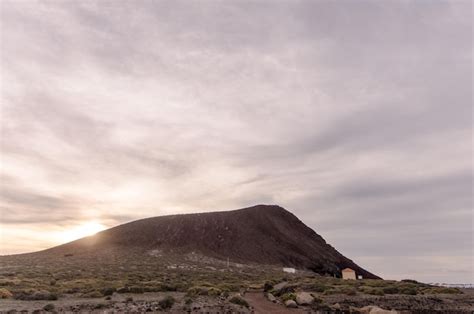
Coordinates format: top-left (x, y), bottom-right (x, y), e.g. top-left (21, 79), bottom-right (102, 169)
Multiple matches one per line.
top-left (0, 249), bottom-right (462, 309)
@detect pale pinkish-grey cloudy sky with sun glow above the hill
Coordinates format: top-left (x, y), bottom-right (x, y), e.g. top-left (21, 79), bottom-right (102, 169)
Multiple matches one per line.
top-left (0, 0), bottom-right (474, 283)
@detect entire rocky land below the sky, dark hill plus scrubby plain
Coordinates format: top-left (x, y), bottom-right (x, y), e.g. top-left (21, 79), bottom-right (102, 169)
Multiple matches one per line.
top-left (0, 205), bottom-right (474, 314)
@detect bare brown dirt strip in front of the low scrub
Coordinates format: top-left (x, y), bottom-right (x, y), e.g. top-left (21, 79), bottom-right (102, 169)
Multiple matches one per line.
top-left (0, 289), bottom-right (474, 314)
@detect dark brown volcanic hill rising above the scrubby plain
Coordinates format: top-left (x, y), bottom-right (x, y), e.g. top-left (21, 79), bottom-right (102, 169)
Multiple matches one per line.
top-left (43, 205), bottom-right (378, 278)
